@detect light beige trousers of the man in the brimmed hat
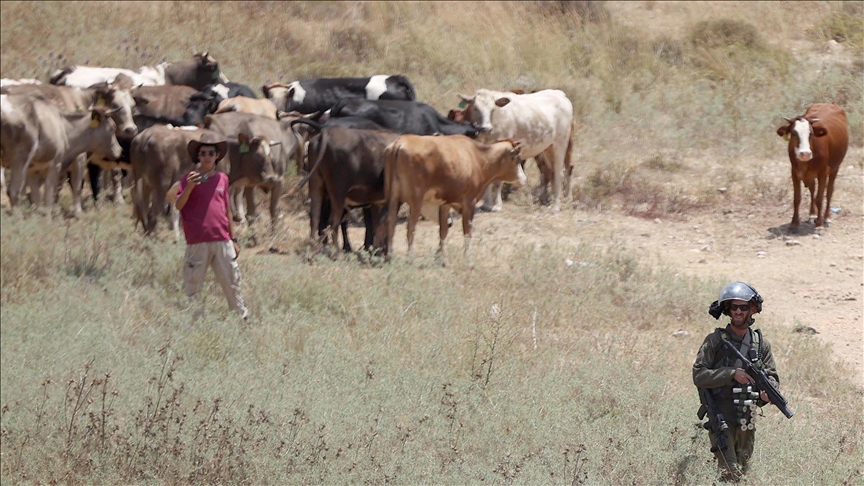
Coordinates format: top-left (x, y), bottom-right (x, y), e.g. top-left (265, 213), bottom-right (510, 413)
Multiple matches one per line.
top-left (183, 240), bottom-right (249, 318)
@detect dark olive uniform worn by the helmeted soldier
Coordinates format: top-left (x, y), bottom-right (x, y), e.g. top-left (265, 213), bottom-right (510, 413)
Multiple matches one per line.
top-left (693, 326), bottom-right (780, 481)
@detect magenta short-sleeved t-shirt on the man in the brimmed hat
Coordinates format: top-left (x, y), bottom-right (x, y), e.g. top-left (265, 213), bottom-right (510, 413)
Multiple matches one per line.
top-left (177, 172), bottom-right (231, 245)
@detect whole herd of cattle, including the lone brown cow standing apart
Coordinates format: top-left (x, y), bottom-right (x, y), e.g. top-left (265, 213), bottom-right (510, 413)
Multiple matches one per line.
top-left (0, 52), bottom-right (848, 264)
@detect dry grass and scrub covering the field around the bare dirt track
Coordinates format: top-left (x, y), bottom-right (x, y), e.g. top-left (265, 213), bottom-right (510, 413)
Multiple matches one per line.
top-left (0, 2), bottom-right (864, 484)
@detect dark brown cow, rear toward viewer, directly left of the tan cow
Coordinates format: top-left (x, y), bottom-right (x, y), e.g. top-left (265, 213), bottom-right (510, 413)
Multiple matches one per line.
top-left (291, 119), bottom-right (399, 252)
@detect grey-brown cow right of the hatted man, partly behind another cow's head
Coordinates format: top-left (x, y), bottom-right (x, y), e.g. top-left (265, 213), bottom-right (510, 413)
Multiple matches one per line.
top-left (204, 113), bottom-right (303, 229)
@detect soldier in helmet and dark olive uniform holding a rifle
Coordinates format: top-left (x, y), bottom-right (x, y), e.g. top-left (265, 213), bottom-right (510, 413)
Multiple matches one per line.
top-left (693, 282), bottom-right (779, 482)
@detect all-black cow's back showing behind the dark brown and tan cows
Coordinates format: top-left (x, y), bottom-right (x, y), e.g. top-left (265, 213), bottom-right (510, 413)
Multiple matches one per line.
top-left (330, 98), bottom-right (479, 138)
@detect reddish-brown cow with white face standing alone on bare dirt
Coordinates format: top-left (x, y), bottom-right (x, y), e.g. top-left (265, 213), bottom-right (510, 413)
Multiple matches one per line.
top-left (777, 103), bottom-right (849, 231)
